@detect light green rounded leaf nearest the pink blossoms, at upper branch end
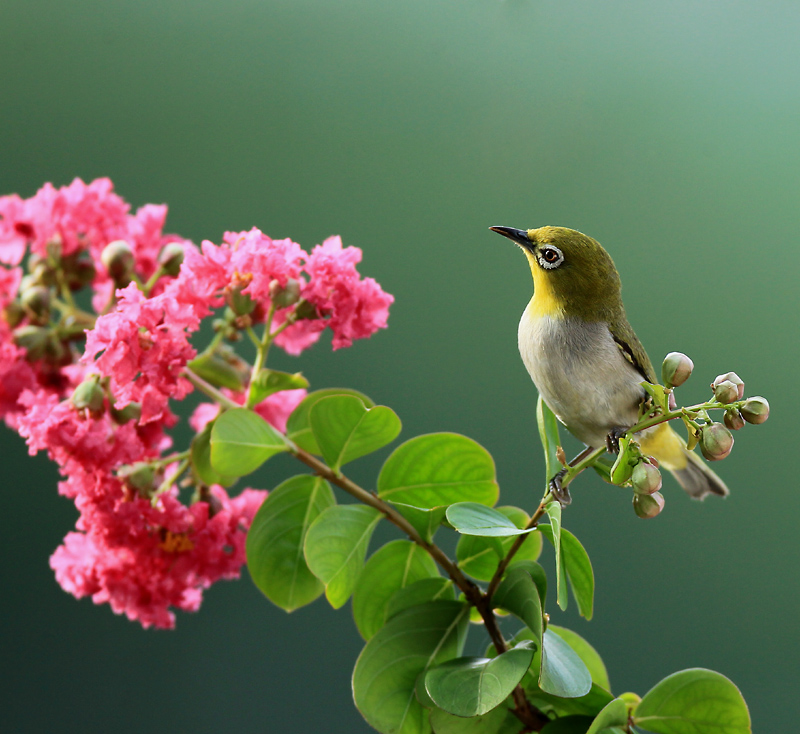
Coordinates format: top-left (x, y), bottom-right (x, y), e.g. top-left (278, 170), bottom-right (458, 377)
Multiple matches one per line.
top-left (211, 408), bottom-right (287, 477)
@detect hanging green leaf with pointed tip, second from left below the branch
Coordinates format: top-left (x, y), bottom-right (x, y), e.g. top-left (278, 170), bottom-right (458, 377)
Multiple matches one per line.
top-left (304, 505), bottom-right (383, 609)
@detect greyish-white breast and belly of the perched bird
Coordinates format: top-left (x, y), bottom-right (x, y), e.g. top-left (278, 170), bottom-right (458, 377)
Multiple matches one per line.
top-left (518, 305), bottom-right (644, 448)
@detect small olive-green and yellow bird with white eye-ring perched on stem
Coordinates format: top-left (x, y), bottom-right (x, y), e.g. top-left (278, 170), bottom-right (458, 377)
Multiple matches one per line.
top-left (490, 227), bottom-right (728, 504)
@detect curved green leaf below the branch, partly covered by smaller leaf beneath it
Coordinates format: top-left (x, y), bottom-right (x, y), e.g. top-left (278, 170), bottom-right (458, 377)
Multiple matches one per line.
top-left (353, 540), bottom-right (439, 640)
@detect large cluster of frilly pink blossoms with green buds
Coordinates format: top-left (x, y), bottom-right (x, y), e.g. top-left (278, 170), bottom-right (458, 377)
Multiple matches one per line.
top-left (0, 179), bottom-right (393, 627)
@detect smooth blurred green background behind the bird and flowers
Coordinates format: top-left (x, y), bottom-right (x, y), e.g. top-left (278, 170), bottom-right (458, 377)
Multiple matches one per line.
top-left (0, 0), bottom-right (800, 734)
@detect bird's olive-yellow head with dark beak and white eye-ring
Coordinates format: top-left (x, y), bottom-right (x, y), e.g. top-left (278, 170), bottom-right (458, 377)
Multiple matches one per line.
top-left (490, 227), bottom-right (622, 321)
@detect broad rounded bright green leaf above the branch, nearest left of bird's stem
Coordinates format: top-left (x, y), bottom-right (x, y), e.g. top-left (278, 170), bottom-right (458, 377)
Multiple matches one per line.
top-left (378, 433), bottom-right (500, 507)
